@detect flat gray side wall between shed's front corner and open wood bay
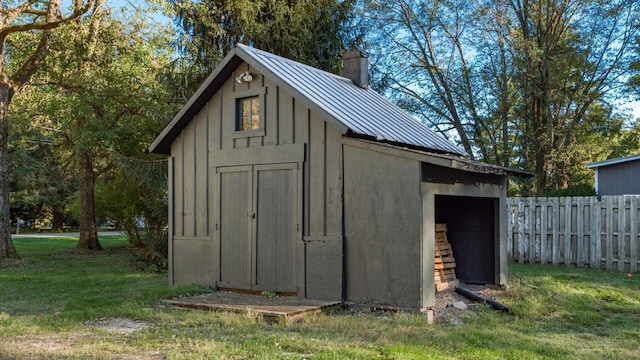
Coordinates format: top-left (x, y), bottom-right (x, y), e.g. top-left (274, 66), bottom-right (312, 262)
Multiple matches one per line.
top-left (343, 145), bottom-right (422, 308)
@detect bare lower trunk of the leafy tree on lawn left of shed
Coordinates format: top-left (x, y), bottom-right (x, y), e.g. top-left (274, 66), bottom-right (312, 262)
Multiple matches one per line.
top-left (78, 153), bottom-right (102, 250)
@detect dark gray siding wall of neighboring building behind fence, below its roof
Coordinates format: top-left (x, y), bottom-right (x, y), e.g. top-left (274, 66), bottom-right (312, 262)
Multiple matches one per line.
top-left (597, 160), bottom-right (640, 196)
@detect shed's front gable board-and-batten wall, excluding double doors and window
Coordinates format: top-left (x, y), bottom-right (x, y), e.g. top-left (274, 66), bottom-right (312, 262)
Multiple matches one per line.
top-left (169, 63), bottom-right (342, 299)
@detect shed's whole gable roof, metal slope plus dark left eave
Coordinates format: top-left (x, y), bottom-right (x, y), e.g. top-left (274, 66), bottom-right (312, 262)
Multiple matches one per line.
top-left (148, 44), bottom-right (466, 155)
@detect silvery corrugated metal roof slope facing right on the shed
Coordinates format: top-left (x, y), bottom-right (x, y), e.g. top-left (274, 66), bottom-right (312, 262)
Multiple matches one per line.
top-left (238, 44), bottom-right (466, 155)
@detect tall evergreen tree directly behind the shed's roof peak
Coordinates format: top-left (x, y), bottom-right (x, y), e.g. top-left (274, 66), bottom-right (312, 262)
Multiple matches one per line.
top-left (169, 0), bottom-right (363, 98)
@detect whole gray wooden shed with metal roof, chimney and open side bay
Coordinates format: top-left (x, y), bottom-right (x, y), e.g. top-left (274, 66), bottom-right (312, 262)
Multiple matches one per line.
top-left (149, 45), bottom-right (524, 310)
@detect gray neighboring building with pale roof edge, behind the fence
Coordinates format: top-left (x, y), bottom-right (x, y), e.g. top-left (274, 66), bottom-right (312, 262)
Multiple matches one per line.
top-left (587, 154), bottom-right (640, 197)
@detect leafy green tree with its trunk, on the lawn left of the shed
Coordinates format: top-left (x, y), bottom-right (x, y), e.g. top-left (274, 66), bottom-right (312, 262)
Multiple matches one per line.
top-left (21, 4), bottom-right (173, 250)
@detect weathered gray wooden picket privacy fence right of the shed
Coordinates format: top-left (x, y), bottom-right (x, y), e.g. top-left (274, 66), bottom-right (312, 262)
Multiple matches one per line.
top-left (507, 196), bottom-right (640, 272)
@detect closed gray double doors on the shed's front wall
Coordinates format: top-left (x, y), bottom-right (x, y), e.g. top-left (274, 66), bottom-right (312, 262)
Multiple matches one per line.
top-left (218, 164), bottom-right (298, 292)
